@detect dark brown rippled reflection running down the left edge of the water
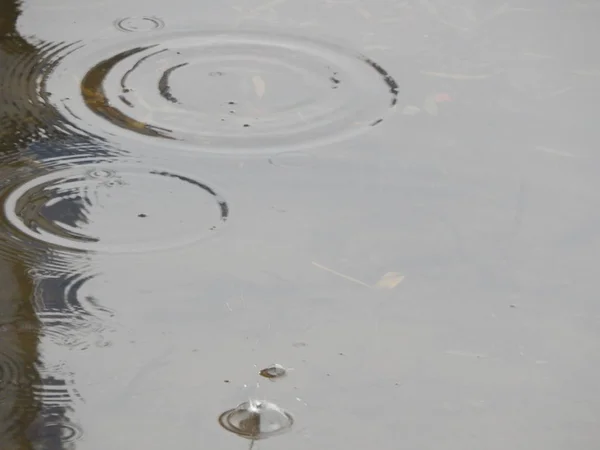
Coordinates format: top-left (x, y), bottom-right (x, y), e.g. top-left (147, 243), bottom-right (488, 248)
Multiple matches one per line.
top-left (0, 1), bottom-right (94, 450)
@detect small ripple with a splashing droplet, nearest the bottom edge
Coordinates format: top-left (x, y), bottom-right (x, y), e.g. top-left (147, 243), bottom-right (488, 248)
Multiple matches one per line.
top-left (219, 400), bottom-right (294, 440)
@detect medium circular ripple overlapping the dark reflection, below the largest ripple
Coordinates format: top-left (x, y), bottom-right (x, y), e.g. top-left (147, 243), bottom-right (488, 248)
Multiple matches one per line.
top-left (4, 164), bottom-right (229, 252)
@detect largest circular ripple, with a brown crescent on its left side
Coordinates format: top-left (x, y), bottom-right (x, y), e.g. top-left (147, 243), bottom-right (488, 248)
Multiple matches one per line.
top-left (49, 32), bottom-right (398, 153)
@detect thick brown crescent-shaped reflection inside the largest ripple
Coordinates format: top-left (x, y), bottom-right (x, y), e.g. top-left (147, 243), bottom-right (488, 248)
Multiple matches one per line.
top-left (81, 46), bottom-right (173, 139)
